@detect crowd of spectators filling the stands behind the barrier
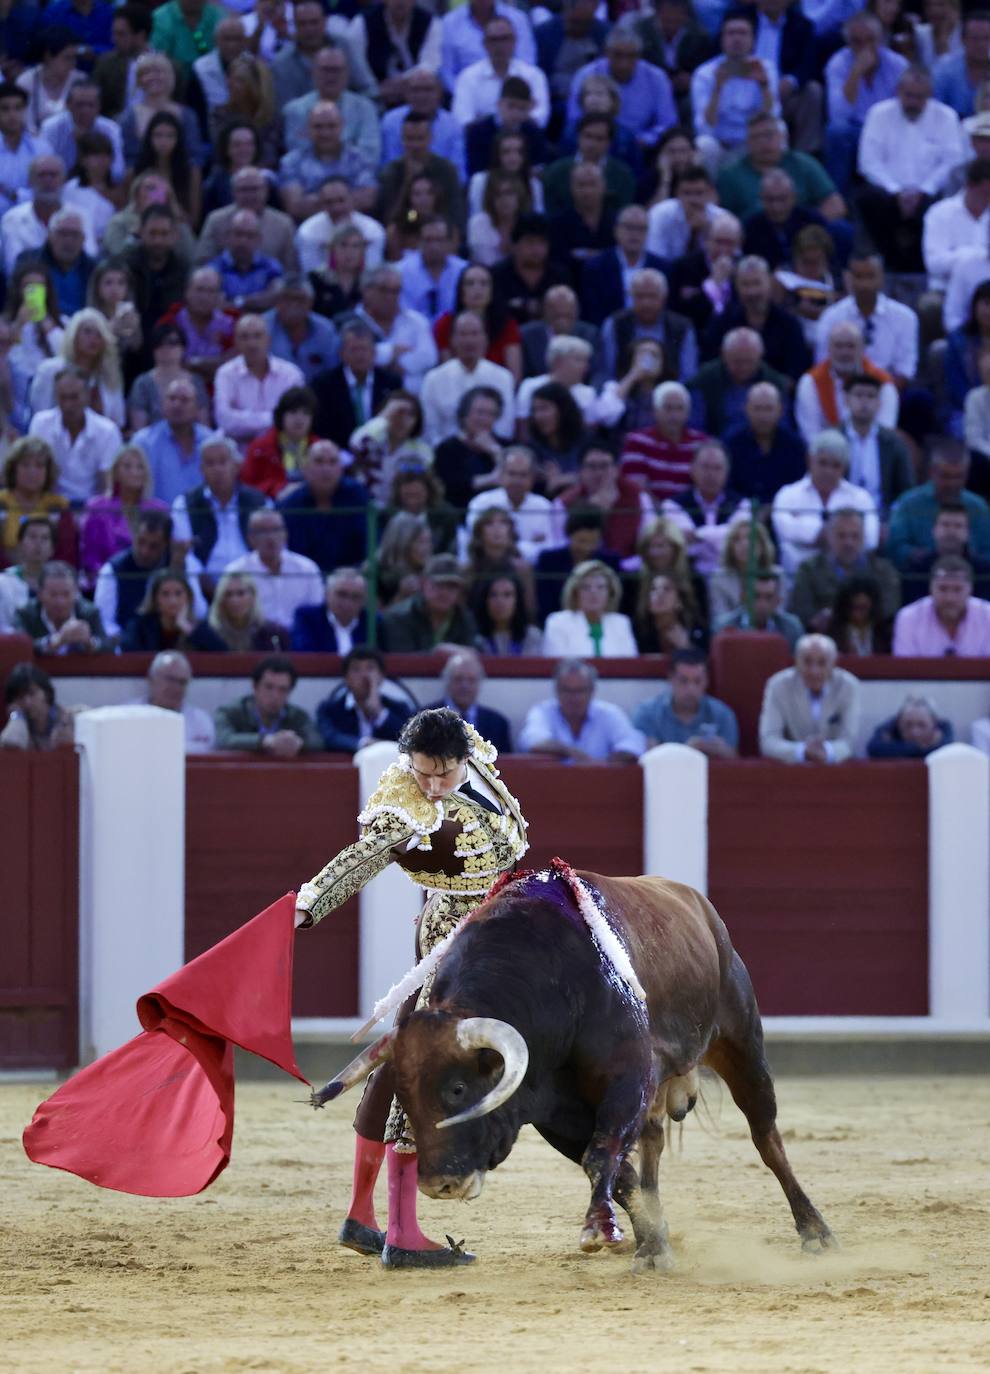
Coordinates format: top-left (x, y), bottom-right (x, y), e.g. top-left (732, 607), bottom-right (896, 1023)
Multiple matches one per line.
top-left (0, 0), bottom-right (990, 761)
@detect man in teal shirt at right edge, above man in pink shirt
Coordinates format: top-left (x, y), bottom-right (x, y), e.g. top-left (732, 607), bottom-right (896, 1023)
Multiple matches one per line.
top-left (887, 440), bottom-right (990, 573)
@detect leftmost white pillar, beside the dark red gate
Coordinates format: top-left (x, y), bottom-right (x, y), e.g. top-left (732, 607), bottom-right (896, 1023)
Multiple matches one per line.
top-left (76, 706), bottom-right (185, 1062)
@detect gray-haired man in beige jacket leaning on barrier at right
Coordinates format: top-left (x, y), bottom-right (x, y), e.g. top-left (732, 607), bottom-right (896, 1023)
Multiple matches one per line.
top-left (759, 635), bottom-right (861, 764)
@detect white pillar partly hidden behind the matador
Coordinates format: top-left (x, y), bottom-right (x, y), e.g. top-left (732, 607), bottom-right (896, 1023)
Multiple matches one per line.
top-left (354, 741), bottom-right (423, 1017)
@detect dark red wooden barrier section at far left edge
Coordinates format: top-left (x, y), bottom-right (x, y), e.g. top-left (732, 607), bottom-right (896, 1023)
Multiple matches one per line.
top-left (0, 749), bottom-right (80, 1069)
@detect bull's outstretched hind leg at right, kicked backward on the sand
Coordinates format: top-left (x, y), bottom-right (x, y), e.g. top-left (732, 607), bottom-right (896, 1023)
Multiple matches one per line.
top-left (704, 955), bottom-right (838, 1250)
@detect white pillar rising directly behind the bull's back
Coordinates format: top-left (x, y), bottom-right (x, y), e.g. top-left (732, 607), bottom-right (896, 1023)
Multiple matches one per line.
top-left (640, 745), bottom-right (709, 892)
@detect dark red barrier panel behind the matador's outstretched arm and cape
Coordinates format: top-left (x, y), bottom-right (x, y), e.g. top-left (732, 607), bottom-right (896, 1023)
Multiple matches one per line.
top-left (185, 756), bottom-right (358, 1017)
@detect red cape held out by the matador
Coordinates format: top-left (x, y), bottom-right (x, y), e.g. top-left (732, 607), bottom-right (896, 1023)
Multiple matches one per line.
top-left (23, 892), bottom-right (308, 1198)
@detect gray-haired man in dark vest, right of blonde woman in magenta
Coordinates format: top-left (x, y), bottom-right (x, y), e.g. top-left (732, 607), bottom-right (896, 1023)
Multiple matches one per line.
top-left (172, 433), bottom-right (270, 580)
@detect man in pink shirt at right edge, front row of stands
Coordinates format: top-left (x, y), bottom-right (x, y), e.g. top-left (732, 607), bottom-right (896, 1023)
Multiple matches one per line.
top-left (894, 555), bottom-right (990, 658)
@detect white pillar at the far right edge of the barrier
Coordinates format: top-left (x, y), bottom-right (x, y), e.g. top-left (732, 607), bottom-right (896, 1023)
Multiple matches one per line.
top-left (925, 745), bottom-right (990, 1024)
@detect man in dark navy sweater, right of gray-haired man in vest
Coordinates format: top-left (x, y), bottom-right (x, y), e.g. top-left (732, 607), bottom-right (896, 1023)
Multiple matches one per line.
top-left (279, 438), bottom-right (368, 571)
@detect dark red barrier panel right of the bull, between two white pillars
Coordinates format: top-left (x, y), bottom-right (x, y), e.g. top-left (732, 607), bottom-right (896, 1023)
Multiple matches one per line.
top-left (709, 760), bottom-right (928, 1015)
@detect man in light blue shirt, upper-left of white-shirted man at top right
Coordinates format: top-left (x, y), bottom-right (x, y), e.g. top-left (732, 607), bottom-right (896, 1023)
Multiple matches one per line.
top-left (824, 10), bottom-right (908, 195)
